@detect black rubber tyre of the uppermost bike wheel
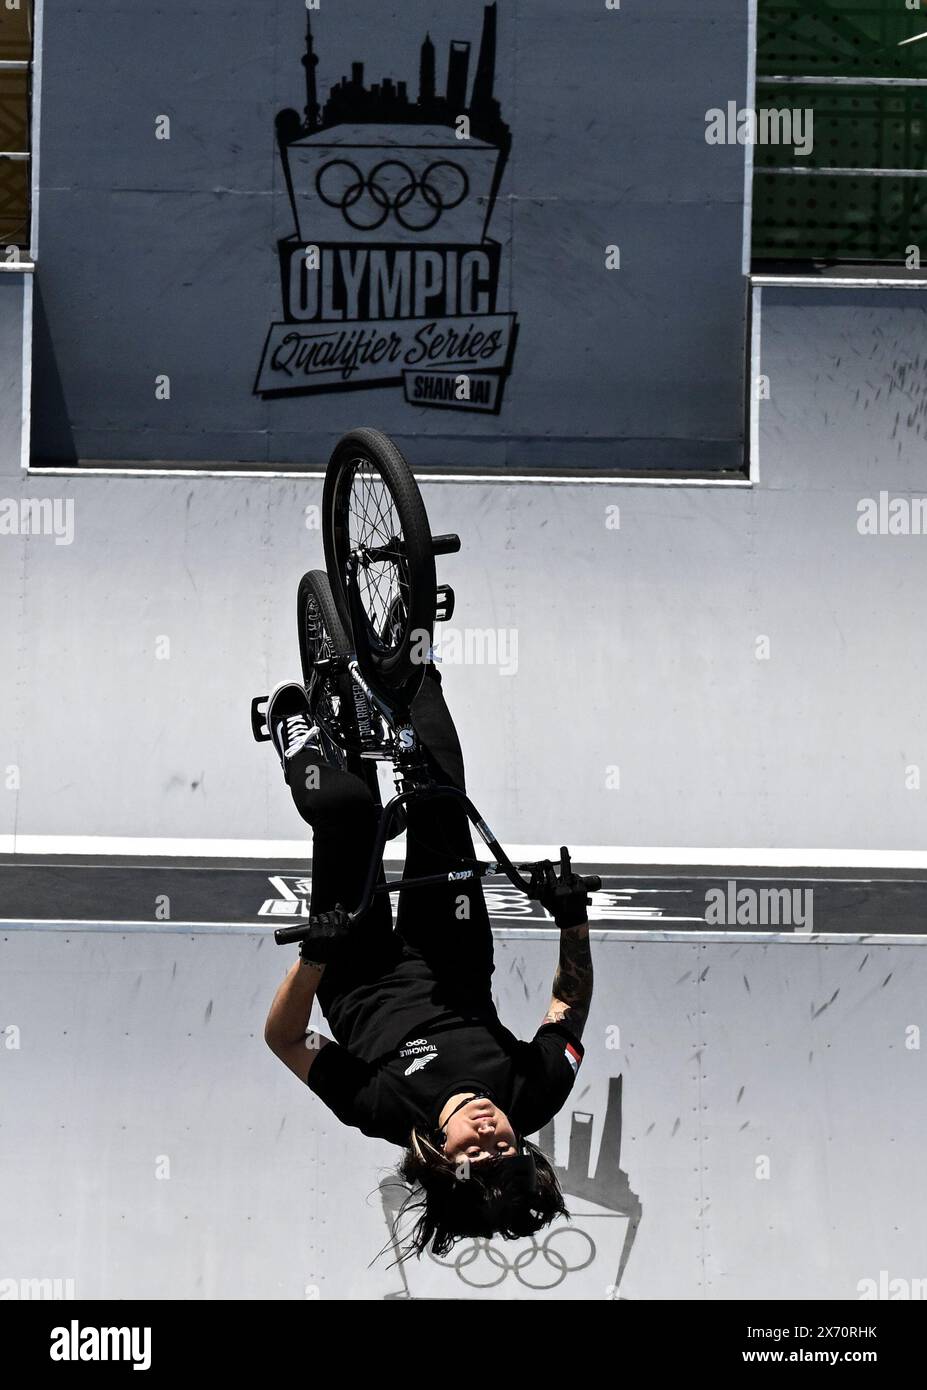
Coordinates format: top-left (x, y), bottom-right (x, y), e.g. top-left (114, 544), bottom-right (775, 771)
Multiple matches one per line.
top-left (322, 428), bottom-right (438, 703)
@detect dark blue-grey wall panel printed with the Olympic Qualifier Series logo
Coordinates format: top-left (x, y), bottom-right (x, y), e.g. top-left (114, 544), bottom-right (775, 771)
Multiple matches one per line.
top-left (33, 0), bottom-right (749, 471)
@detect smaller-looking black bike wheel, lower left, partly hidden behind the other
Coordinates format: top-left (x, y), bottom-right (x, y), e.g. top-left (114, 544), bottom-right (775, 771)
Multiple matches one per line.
top-left (296, 570), bottom-right (379, 802)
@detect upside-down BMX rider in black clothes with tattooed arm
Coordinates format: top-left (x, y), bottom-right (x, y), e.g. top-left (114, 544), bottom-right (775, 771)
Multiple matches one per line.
top-left (264, 664), bottom-right (592, 1255)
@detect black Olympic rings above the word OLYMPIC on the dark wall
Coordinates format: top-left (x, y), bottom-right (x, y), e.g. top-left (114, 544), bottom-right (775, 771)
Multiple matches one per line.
top-left (315, 160), bottom-right (470, 232)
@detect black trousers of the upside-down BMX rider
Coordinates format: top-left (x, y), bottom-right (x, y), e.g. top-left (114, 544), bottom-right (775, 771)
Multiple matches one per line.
top-left (289, 666), bottom-right (493, 1020)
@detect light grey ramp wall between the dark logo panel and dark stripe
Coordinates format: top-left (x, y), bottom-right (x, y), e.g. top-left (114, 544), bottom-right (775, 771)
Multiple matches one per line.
top-left (0, 291), bottom-right (927, 849)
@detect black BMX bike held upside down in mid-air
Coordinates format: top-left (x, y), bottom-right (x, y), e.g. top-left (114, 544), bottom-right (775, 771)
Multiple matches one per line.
top-left (252, 430), bottom-right (602, 945)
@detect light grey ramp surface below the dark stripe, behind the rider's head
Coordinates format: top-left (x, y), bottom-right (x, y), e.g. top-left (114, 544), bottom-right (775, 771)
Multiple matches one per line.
top-left (0, 930), bottom-right (927, 1301)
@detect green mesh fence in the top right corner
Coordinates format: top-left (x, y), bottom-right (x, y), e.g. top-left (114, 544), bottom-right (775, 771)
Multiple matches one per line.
top-left (753, 0), bottom-right (927, 264)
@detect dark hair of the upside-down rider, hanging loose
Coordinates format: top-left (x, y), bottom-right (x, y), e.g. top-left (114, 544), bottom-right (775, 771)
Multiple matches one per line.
top-left (395, 1129), bottom-right (570, 1259)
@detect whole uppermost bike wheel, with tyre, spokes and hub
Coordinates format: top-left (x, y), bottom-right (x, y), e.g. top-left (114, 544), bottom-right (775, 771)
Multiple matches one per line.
top-left (322, 430), bottom-right (436, 705)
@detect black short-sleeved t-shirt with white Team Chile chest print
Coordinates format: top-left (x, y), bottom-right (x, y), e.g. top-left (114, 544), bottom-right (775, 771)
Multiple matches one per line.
top-left (307, 1009), bottom-right (584, 1147)
